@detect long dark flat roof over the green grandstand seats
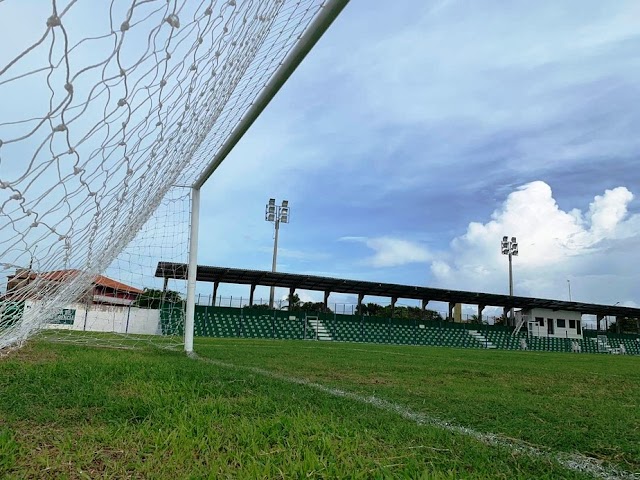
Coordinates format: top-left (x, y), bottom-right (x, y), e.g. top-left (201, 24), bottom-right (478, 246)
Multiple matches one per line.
top-left (156, 262), bottom-right (640, 318)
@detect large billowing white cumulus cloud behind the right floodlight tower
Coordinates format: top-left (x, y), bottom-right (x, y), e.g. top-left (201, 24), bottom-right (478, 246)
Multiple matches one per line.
top-left (431, 181), bottom-right (640, 303)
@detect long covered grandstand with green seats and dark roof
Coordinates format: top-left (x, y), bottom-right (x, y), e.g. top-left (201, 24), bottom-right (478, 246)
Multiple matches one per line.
top-left (156, 262), bottom-right (640, 355)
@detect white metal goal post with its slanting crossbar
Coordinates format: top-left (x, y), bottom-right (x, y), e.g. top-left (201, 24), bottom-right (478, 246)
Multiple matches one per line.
top-left (184, 0), bottom-right (349, 353)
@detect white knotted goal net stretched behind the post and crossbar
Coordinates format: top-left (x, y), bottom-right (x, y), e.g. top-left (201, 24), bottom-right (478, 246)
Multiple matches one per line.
top-left (0, 0), bottom-right (324, 350)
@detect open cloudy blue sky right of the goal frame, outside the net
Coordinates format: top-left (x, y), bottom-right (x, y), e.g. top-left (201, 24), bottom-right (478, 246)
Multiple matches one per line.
top-left (190, 0), bottom-right (640, 316)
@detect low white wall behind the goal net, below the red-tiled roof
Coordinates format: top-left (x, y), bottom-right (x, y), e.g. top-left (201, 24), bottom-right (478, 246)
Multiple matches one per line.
top-left (25, 300), bottom-right (162, 335)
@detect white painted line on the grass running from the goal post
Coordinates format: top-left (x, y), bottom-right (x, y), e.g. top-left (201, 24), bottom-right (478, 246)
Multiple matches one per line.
top-left (194, 353), bottom-right (640, 480)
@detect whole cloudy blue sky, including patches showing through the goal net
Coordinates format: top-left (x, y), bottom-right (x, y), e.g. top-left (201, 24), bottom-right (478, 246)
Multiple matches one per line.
top-left (0, 0), bottom-right (640, 318)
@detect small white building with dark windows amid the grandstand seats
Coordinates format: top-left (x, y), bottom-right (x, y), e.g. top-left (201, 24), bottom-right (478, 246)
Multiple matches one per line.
top-left (516, 308), bottom-right (582, 338)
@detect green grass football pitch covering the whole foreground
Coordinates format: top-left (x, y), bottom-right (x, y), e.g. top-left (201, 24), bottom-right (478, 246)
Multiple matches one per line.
top-left (0, 339), bottom-right (640, 479)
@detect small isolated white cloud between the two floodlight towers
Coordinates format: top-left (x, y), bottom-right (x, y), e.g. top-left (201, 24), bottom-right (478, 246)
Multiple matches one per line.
top-left (340, 237), bottom-right (433, 268)
